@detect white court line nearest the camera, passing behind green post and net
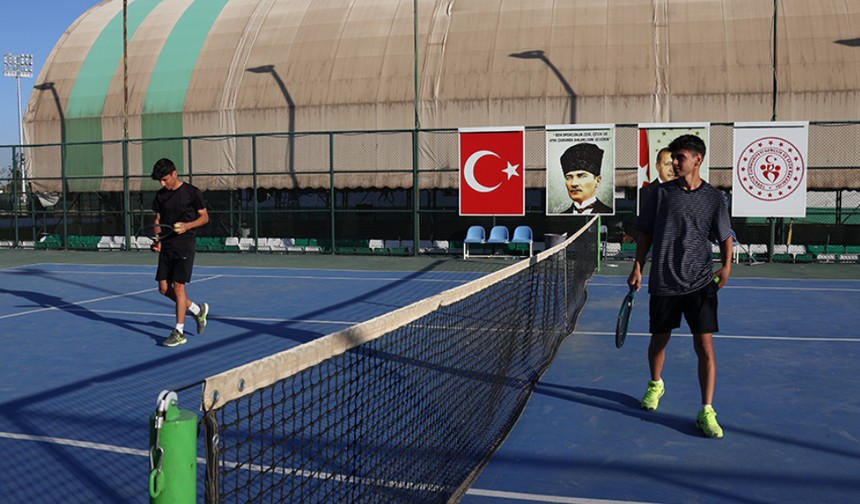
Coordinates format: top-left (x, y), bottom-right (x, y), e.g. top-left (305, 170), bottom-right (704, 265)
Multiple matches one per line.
top-left (0, 432), bottom-right (650, 504)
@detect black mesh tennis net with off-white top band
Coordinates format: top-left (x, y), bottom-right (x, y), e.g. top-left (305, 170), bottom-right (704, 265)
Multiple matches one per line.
top-left (203, 218), bottom-right (598, 503)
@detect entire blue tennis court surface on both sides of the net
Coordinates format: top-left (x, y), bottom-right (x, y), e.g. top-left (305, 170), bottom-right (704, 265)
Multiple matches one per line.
top-left (0, 241), bottom-right (860, 504)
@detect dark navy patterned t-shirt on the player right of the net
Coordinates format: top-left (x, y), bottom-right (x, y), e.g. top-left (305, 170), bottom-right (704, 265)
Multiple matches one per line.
top-left (634, 180), bottom-right (732, 296)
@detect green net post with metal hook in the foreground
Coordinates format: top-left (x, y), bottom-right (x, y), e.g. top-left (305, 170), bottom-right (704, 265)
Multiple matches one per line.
top-left (149, 390), bottom-right (197, 504)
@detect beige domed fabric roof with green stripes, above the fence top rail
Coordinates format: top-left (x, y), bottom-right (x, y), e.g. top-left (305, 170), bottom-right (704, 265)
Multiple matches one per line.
top-left (25, 0), bottom-right (860, 190)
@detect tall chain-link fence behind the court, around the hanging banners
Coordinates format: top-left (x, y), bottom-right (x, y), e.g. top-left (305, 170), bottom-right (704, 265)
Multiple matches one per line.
top-left (0, 123), bottom-right (860, 262)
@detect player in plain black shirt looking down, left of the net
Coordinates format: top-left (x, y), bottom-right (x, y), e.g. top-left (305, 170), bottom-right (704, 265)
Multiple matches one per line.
top-left (152, 158), bottom-right (209, 347)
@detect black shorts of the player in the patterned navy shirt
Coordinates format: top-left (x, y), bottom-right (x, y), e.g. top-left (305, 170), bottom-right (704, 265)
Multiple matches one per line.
top-left (649, 282), bottom-right (720, 334)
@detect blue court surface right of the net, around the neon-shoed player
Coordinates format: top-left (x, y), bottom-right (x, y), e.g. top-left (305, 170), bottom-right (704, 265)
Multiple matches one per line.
top-left (461, 276), bottom-right (860, 504)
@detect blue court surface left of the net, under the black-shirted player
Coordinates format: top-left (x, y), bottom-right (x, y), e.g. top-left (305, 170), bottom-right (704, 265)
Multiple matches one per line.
top-left (0, 264), bottom-right (481, 503)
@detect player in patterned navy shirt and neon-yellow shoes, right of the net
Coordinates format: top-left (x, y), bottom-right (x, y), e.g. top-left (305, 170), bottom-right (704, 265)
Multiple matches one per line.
top-left (627, 135), bottom-right (732, 438)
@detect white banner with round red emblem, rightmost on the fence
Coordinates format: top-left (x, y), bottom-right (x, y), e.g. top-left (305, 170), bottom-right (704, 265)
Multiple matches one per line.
top-left (732, 122), bottom-right (809, 217)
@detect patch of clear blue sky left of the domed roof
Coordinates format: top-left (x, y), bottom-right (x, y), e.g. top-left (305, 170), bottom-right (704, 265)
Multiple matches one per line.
top-left (0, 0), bottom-right (100, 172)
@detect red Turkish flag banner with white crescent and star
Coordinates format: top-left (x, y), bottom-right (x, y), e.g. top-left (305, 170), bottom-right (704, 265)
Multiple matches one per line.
top-left (459, 127), bottom-right (526, 216)
